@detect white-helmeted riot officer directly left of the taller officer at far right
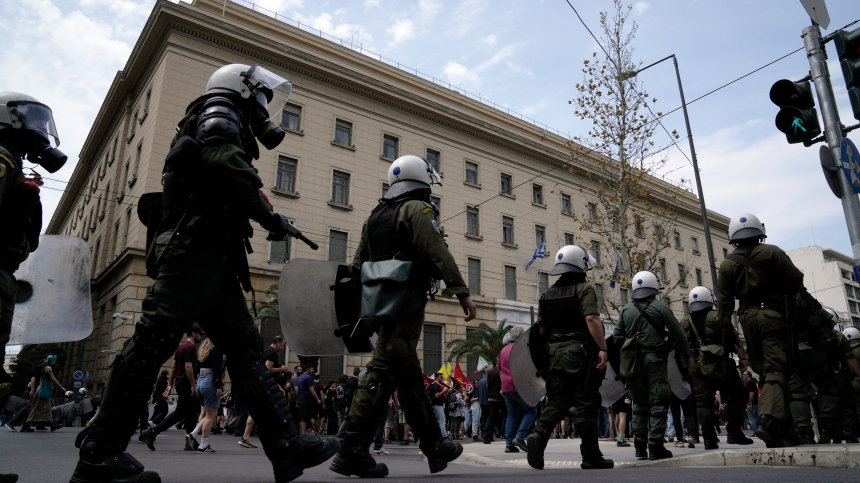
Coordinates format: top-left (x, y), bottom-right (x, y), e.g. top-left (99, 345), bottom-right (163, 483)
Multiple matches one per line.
top-left (681, 287), bottom-right (753, 450)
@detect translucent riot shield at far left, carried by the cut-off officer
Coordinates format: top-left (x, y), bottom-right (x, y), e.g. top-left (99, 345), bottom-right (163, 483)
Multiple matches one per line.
top-left (8, 235), bottom-right (93, 345)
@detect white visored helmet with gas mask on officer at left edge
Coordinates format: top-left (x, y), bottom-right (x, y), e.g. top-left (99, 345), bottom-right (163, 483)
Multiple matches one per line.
top-left (0, 92), bottom-right (68, 173)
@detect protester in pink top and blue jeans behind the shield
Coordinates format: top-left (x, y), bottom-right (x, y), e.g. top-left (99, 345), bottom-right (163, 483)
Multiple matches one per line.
top-left (499, 327), bottom-right (537, 453)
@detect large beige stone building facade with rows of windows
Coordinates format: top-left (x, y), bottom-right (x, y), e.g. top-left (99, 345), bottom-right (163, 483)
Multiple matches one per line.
top-left (47, 0), bottom-right (729, 392)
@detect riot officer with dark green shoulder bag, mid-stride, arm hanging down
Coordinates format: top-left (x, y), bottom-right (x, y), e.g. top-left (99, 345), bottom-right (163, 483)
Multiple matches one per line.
top-left (330, 155), bottom-right (476, 478)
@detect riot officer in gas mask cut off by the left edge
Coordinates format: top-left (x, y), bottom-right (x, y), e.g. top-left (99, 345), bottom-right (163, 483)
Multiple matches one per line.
top-left (0, 92), bottom-right (67, 481)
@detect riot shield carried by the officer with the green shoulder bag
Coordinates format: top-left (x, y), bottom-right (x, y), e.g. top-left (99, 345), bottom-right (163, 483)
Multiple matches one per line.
top-left (278, 258), bottom-right (375, 356)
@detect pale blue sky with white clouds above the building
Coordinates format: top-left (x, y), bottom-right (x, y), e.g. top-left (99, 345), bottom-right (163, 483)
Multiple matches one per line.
top-left (0, 0), bottom-right (860, 255)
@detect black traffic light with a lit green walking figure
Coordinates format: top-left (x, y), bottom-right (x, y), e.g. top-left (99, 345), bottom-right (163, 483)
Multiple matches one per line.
top-left (770, 79), bottom-right (821, 144)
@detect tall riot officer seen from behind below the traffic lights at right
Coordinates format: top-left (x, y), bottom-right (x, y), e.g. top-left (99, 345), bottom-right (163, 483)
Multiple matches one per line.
top-left (717, 213), bottom-right (803, 448)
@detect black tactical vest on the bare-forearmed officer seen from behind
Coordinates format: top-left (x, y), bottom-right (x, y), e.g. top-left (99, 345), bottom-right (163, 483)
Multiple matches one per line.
top-left (541, 282), bottom-right (589, 342)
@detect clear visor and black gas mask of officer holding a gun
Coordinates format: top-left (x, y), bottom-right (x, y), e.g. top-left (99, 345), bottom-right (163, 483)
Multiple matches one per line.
top-left (242, 65), bottom-right (293, 150)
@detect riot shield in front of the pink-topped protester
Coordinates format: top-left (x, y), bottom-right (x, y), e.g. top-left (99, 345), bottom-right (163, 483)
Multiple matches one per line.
top-left (508, 326), bottom-right (546, 406)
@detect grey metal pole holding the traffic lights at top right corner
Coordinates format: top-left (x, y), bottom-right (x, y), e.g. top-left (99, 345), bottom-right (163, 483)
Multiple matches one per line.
top-left (802, 25), bottom-right (860, 265)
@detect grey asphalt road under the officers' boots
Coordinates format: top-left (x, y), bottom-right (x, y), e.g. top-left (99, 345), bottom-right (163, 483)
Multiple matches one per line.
top-left (0, 428), bottom-right (860, 483)
